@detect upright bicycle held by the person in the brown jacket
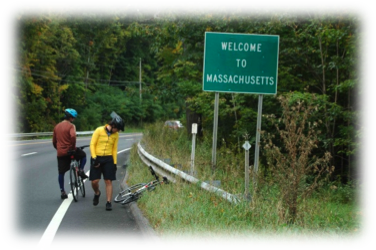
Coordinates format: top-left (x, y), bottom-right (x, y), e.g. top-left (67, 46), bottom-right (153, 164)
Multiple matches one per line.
top-left (68, 145), bottom-right (90, 202)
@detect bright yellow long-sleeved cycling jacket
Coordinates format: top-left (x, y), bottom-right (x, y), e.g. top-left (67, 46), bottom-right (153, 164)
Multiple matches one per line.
top-left (90, 125), bottom-right (119, 164)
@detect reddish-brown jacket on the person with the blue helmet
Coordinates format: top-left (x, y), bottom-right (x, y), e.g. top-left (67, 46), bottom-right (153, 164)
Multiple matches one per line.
top-left (52, 120), bottom-right (76, 157)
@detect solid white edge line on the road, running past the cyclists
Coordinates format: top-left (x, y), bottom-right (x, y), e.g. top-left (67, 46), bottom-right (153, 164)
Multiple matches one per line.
top-left (37, 148), bottom-right (131, 248)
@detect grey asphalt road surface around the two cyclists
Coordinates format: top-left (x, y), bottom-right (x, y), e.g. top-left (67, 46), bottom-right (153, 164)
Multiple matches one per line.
top-left (2, 134), bottom-right (160, 247)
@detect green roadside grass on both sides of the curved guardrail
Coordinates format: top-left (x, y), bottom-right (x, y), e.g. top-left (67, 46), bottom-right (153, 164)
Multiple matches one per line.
top-left (128, 123), bottom-right (373, 247)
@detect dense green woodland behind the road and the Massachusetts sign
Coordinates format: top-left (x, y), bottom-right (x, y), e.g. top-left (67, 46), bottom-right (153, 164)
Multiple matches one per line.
top-left (4, 3), bottom-right (371, 184)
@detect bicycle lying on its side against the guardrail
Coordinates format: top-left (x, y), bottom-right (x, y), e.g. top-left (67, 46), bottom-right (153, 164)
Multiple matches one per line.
top-left (114, 166), bottom-right (169, 205)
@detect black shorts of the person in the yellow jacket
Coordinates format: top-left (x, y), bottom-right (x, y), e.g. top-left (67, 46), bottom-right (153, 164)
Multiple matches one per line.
top-left (89, 155), bottom-right (116, 181)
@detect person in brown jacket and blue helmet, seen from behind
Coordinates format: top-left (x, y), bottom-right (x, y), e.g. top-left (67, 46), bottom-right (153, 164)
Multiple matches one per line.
top-left (52, 108), bottom-right (88, 199)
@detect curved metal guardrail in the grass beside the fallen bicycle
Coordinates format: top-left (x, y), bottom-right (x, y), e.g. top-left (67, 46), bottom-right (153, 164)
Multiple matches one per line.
top-left (137, 143), bottom-right (240, 204)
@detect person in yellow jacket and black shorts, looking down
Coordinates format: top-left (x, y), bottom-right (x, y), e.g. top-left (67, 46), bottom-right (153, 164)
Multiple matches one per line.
top-left (89, 115), bottom-right (124, 210)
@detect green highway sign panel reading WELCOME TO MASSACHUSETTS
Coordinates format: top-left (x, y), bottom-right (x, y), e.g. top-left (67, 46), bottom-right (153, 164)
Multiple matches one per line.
top-left (203, 32), bottom-right (279, 95)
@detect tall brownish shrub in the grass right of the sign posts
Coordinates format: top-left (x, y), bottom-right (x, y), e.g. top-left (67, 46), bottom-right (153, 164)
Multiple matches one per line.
top-left (262, 93), bottom-right (334, 223)
